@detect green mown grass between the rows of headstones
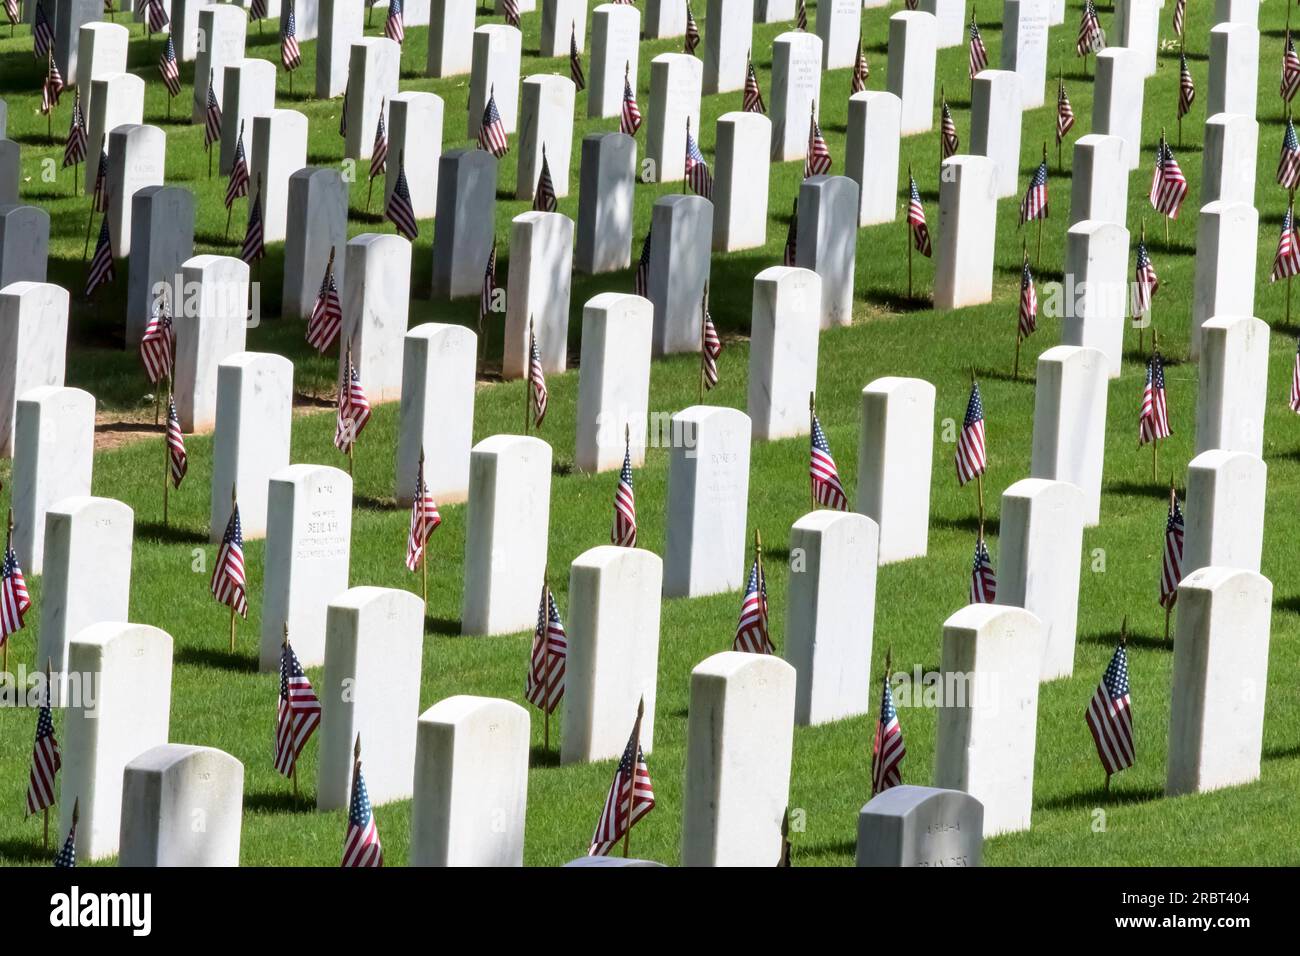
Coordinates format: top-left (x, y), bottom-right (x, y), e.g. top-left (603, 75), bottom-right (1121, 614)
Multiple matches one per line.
top-left (0, 0), bottom-right (1300, 866)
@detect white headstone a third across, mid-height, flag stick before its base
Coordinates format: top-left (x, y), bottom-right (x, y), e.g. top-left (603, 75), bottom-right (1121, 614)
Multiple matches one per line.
top-left (393, 323), bottom-right (478, 506)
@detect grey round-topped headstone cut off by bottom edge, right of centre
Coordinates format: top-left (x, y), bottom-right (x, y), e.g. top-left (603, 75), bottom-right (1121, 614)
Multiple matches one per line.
top-left (857, 784), bottom-right (984, 866)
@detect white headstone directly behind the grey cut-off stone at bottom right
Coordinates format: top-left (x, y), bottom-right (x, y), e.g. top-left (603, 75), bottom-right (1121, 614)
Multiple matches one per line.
top-left (935, 604), bottom-right (1047, 836)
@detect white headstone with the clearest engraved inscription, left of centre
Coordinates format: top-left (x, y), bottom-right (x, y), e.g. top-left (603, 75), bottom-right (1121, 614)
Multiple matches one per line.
top-left (257, 464), bottom-right (352, 671)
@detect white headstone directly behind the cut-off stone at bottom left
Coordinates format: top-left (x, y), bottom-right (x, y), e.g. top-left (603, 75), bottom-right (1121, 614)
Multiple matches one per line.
top-left (56, 623), bottom-right (172, 862)
